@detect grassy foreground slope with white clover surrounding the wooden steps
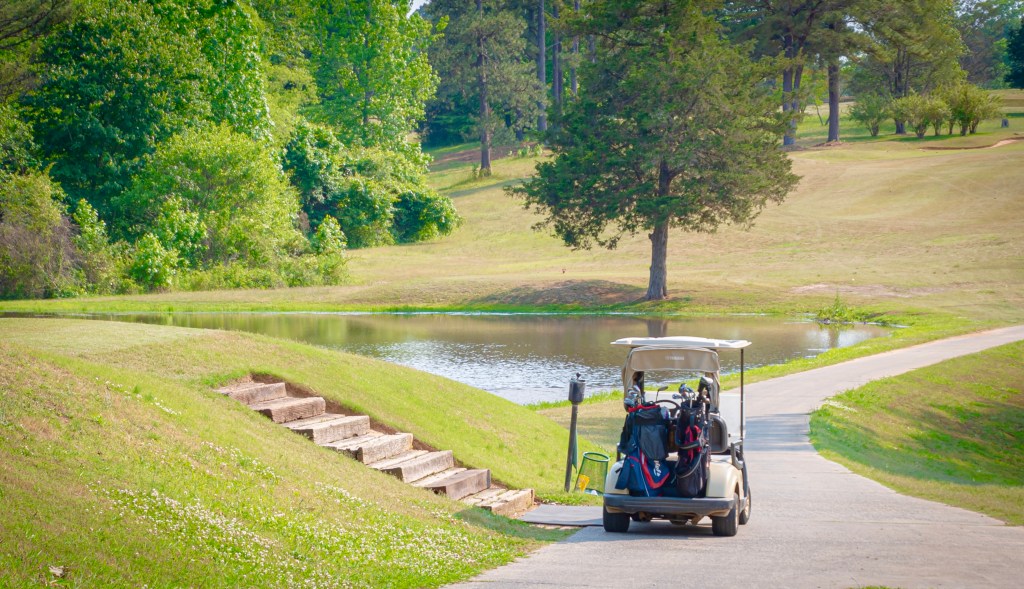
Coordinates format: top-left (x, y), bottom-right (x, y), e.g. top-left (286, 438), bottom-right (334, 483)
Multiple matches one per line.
top-left (0, 320), bottom-right (577, 587)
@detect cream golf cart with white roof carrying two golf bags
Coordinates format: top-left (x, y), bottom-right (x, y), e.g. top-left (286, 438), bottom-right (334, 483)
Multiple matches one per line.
top-left (604, 337), bottom-right (751, 536)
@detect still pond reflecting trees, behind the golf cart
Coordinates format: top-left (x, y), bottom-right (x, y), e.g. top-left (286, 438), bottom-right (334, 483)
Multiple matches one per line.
top-left (72, 312), bottom-right (889, 404)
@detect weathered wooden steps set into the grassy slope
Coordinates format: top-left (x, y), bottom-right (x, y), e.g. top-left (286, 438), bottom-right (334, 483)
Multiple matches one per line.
top-left (217, 381), bottom-right (534, 516)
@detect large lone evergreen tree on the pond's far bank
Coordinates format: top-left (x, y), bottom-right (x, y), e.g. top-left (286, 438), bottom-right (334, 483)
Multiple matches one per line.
top-left (510, 0), bottom-right (797, 300)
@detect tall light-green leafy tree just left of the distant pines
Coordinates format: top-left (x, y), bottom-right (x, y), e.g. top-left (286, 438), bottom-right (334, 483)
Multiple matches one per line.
top-left (314, 0), bottom-right (444, 158)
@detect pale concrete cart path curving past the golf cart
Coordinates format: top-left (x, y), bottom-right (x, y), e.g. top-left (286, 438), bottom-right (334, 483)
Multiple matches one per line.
top-left (458, 326), bottom-right (1024, 588)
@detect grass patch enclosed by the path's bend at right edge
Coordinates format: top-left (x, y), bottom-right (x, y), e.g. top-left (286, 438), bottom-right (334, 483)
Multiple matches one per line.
top-left (811, 342), bottom-right (1024, 525)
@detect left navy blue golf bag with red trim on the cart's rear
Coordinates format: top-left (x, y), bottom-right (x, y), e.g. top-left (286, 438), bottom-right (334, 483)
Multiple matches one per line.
top-left (615, 405), bottom-right (674, 497)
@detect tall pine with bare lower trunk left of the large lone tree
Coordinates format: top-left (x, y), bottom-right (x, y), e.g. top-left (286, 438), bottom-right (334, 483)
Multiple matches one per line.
top-left (427, 0), bottom-right (544, 170)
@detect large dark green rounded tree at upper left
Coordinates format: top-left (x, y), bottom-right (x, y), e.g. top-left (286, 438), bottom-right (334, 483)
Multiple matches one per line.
top-left (24, 0), bottom-right (212, 221)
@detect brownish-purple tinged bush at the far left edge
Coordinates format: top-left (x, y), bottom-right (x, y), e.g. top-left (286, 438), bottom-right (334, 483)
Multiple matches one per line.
top-left (0, 172), bottom-right (80, 298)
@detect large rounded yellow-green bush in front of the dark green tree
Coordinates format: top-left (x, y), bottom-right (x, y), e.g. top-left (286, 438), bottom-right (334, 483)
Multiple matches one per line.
top-left (120, 125), bottom-right (307, 268)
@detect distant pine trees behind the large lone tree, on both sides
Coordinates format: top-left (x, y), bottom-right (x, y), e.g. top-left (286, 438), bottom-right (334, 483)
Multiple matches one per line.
top-left (421, 0), bottom-right (1024, 158)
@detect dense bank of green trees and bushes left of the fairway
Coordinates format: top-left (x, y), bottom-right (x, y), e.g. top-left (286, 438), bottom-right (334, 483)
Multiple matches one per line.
top-left (0, 0), bottom-right (459, 297)
